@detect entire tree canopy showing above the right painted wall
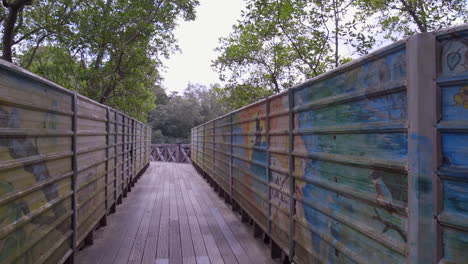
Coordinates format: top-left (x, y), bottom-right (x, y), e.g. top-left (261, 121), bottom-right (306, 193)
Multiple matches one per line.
top-left (213, 0), bottom-right (468, 107)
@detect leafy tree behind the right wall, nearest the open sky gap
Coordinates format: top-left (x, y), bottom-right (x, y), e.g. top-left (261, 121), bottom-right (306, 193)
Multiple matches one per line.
top-left (213, 0), bottom-right (373, 102)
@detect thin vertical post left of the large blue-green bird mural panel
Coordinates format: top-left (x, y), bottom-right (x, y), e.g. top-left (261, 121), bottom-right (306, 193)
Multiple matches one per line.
top-left (288, 89), bottom-right (295, 262)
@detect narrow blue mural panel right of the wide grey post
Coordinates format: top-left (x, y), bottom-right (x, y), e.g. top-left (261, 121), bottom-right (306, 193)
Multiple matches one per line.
top-left (438, 32), bottom-right (468, 264)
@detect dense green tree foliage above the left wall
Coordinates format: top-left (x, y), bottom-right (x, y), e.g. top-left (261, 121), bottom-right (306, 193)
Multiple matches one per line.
top-left (0, 0), bottom-right (198, 121)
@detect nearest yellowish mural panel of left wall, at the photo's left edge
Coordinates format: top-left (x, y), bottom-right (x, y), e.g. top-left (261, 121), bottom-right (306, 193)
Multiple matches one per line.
top-left (0, 68), bottom-right (72, 263)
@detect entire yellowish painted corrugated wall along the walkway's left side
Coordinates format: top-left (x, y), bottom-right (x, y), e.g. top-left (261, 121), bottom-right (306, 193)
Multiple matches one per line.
top-left (0, 60), bottom-right (151, 264)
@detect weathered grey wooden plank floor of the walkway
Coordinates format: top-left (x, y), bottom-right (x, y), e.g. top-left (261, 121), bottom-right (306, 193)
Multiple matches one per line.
top-left (76, 162), bottom-right (275, 264)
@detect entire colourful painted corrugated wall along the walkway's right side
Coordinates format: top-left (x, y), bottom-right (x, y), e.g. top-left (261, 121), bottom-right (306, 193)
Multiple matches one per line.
top-left (193, 25), bottom-right (468, 263)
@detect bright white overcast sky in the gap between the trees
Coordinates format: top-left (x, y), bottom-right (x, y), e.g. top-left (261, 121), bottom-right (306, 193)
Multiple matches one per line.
top-left (163, 0), bottom-right (244, 92)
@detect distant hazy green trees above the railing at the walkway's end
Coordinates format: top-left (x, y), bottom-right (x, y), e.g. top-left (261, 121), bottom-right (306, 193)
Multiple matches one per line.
top-left (149, 84), bottom-right (225, 143)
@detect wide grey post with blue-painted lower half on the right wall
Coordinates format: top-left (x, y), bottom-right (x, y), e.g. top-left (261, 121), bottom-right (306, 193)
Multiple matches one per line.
top-left (406, 33), bottom-right (438, 264)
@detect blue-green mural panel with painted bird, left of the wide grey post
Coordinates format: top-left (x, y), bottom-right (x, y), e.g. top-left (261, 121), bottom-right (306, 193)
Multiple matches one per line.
top-left (294, 49), bottom-right (408, 263)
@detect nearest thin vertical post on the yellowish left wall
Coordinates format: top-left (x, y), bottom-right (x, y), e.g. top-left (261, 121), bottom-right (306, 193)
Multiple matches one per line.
top-left (72, 91), bottom-right (78, 255)
